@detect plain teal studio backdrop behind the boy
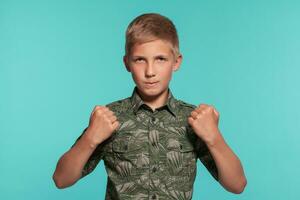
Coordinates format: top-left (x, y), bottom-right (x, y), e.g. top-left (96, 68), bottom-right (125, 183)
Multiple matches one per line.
top-left (0, 0), bottom-right (300, 200)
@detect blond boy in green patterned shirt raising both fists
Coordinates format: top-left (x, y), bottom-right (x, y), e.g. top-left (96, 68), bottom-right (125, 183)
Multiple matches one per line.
top-left (53, 13), bottom-right (247, 200)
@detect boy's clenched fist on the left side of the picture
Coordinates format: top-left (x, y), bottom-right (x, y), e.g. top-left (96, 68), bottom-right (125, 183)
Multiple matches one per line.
top-left (86, 106), bottom-right (119, 145)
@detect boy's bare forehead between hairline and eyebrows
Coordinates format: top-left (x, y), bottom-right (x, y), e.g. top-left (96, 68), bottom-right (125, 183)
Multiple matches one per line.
top-left (131, 39), bottom-right (172, 56)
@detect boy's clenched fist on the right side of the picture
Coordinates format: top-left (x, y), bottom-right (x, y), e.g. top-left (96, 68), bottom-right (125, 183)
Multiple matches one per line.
top-left (188, 104), bottom-right (220, 144)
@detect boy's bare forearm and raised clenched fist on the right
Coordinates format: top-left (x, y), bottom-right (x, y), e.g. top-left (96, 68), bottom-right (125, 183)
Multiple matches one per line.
top-left (188, 104), bottom-right (247, 194)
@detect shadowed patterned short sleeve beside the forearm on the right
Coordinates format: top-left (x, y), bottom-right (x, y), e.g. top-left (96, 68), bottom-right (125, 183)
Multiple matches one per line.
top-left (196, 137), bottom-right (219, 181)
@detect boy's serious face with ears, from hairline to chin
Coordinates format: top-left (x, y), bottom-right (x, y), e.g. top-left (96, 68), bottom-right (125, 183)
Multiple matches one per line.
top-left (124, 39), bottom-right (182, 101)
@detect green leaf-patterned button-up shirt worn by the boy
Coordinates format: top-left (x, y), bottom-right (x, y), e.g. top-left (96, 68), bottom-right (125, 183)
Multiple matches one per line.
top-left (73, 87), bottom-right (218, 200)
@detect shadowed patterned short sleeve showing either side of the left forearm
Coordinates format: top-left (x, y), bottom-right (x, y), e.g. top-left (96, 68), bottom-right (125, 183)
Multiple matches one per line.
top-left (71, 128), bottom-right (104, 178)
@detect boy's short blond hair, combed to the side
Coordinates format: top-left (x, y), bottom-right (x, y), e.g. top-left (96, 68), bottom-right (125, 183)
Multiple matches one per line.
top-left (125, 13), bottom-right (180, 57)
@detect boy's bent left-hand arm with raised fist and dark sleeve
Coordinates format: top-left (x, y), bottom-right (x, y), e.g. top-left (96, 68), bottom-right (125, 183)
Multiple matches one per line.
top-left (52, 106), bottom-right (119, 188)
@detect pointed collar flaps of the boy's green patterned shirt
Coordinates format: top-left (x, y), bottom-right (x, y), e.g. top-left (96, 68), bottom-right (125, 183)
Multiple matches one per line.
top-left (130, 86), bottom-right (177, 117)
